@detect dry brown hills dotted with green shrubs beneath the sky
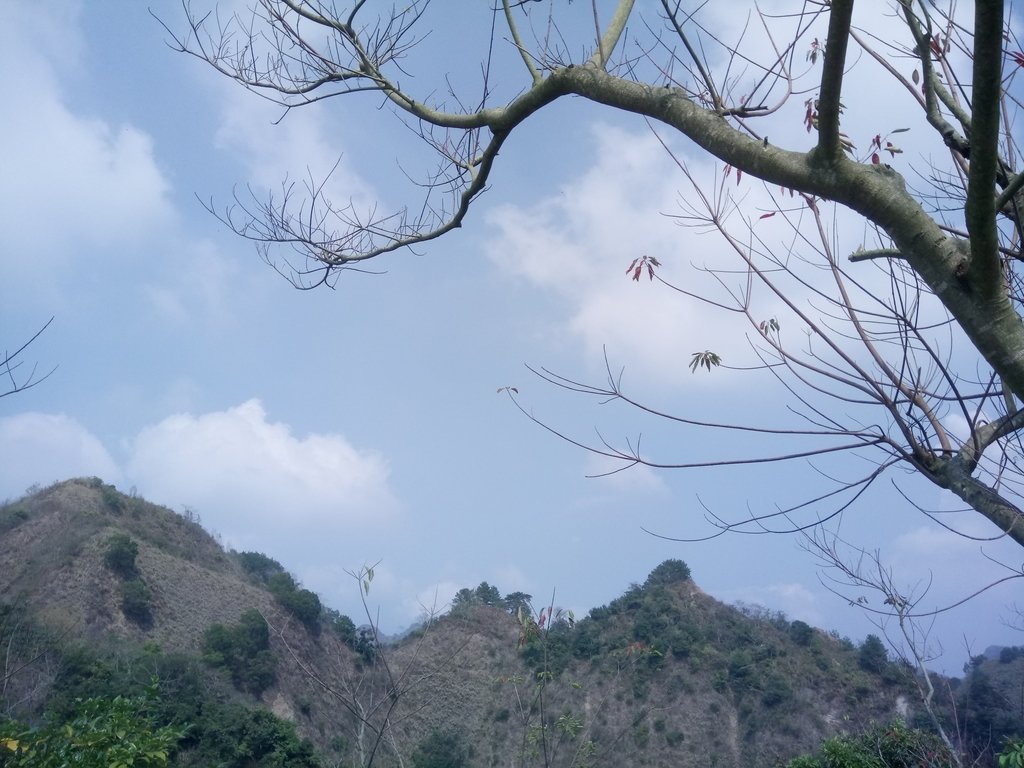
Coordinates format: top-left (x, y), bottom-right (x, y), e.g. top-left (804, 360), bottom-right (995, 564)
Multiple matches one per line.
top-left (0, 478), bottom-right (1007, 768)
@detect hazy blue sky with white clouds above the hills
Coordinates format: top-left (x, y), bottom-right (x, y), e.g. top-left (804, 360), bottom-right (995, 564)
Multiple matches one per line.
top-left (0, 0), bottom-right (1021, 674)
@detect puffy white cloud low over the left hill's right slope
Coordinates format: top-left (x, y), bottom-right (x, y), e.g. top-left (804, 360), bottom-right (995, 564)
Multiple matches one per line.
top-left (127, 399), bottom-right (395, 541)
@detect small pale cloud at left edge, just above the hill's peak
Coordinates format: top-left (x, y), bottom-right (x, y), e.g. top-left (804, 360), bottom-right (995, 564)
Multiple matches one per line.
top-left (0, 413), bottom-right (121, 497)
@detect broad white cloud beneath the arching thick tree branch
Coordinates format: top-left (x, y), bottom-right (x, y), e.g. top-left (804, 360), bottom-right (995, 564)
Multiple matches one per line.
top-left (486, 125), bottom-right (770, 393)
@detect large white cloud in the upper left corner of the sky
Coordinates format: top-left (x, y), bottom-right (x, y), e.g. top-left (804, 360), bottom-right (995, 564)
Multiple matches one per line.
top-left (0, 3), bottom-right (171, 296)
